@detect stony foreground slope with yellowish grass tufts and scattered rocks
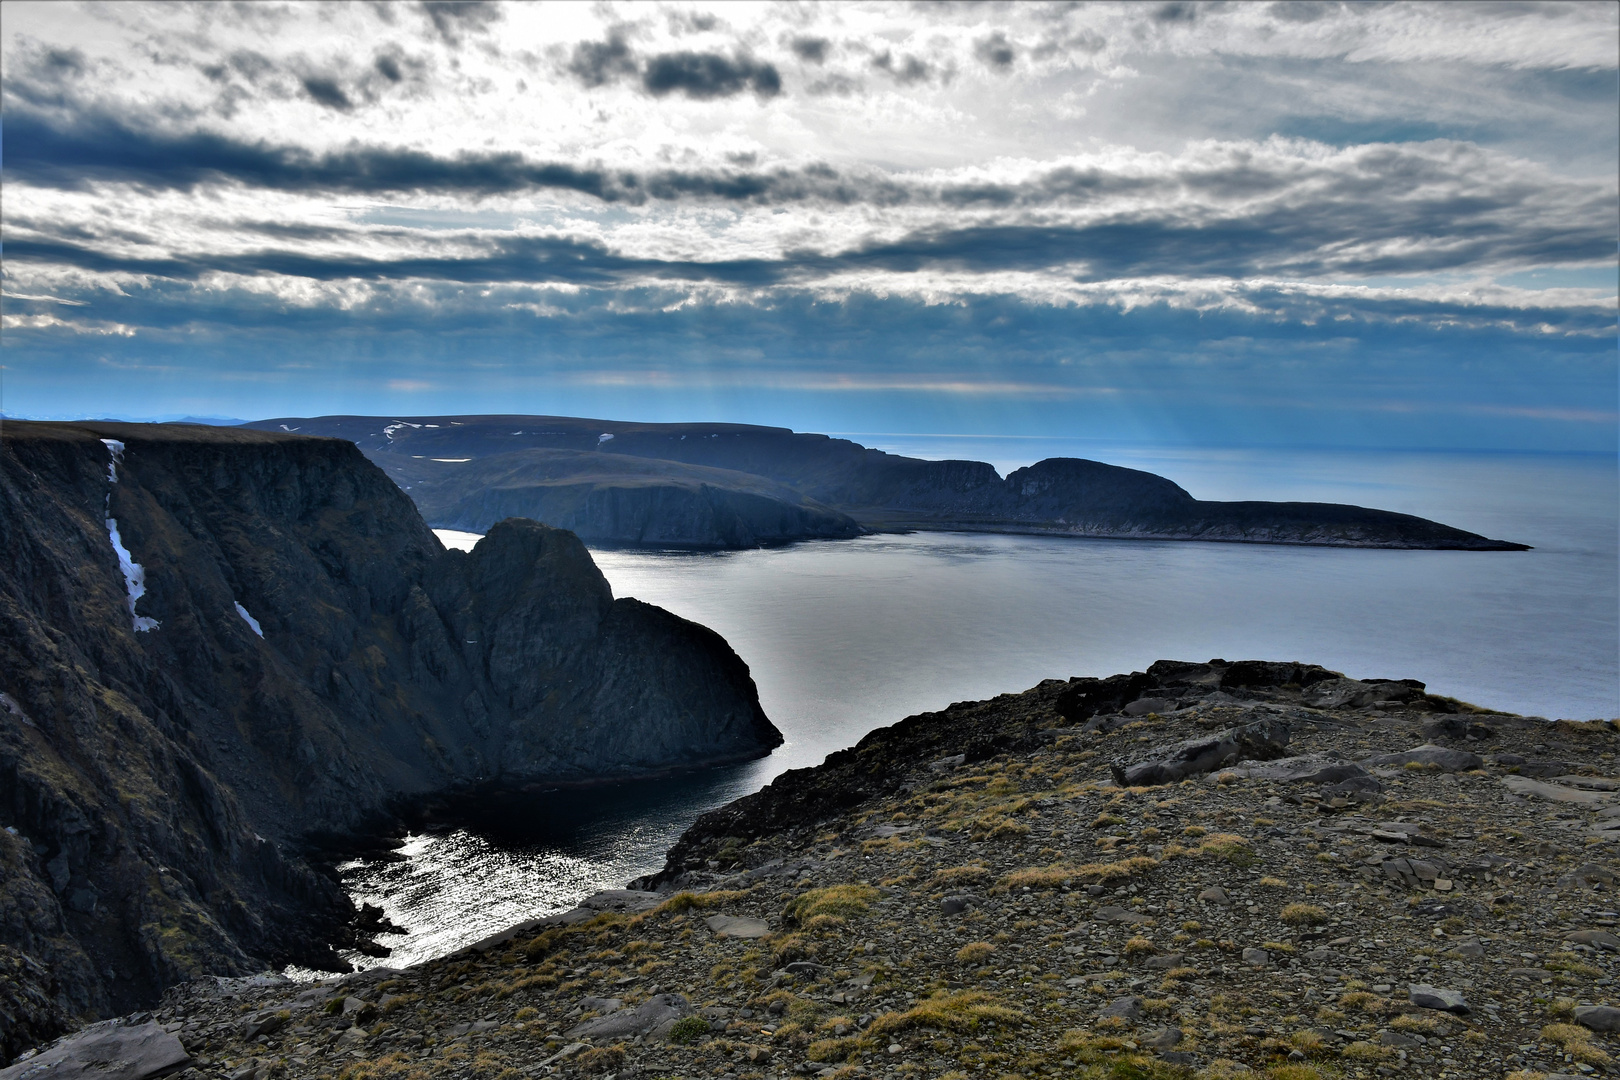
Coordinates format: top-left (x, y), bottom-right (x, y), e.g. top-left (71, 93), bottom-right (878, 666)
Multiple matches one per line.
top-left (0, 662), bottom-right (1620, 1080)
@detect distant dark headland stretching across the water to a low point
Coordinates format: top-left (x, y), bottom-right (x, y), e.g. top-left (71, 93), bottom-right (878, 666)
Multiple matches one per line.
top-left (246, 416), bottom-right (1528, 551)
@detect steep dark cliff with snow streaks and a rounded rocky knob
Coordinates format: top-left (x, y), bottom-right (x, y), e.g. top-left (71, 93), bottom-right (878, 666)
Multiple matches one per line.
top-left (0, 423), bottom-right (781, 1041)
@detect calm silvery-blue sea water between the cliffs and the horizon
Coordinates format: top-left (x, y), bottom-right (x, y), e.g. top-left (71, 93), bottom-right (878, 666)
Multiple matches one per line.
top-left (322, 446), bottom-right (1620, 963)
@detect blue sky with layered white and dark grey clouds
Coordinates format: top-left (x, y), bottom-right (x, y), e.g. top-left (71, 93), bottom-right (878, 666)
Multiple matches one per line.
top-left (0, 2), bottom-right (1620, 452)
